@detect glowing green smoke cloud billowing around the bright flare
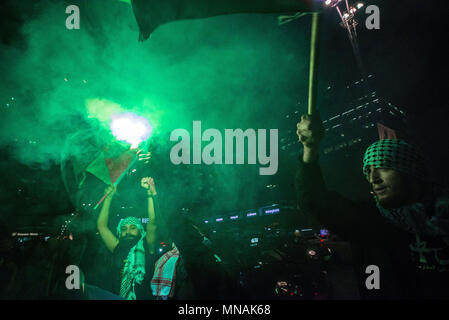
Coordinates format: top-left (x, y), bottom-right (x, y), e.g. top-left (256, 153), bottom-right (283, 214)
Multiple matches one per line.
top-left (0, 0), bottom-right (310, 219)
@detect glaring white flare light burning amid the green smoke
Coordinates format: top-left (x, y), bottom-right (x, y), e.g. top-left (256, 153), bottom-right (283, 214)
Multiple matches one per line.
top-left (111, 113), bottom-right (153, 149)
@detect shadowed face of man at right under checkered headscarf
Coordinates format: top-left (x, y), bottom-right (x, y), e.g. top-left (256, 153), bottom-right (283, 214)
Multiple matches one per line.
top-left (367, 166), bottom-right (410, 209)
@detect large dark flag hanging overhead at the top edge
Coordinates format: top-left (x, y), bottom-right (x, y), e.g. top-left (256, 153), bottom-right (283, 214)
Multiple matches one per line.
top-left (131, 0), bottom-right (313, 41)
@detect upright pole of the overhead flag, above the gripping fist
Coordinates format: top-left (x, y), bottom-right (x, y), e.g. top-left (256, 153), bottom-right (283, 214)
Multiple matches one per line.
top-left (308, 12), bottom-right (320, 115)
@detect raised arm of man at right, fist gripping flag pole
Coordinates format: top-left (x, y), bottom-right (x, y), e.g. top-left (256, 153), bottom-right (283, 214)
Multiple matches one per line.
top-left (295, 114), bottom-right (392, 240)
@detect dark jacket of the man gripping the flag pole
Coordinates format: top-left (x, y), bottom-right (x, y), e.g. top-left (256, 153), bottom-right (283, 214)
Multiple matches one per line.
top-left (296, 160), bottom-right (449, 299)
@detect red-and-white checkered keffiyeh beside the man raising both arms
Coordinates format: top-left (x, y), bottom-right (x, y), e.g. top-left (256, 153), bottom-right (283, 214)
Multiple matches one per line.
top-left (151, 247), bottom-right (179, 299)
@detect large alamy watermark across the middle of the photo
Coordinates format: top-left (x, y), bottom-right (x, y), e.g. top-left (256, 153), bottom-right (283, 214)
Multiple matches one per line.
top-left (170, 121), bottom-right (278, 175)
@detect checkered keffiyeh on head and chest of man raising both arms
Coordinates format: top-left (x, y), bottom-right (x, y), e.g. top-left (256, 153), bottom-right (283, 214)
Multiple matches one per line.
top-left (117, 217), bottom-right (146, 300)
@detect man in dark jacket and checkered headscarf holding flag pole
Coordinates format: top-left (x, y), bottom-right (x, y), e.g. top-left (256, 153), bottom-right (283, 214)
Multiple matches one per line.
top-left (296, 115), bottom-right (449, 299)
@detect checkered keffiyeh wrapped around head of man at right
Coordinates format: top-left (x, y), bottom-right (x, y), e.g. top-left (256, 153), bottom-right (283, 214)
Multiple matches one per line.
top-left (363, 139), bottom-right (426, 180)
